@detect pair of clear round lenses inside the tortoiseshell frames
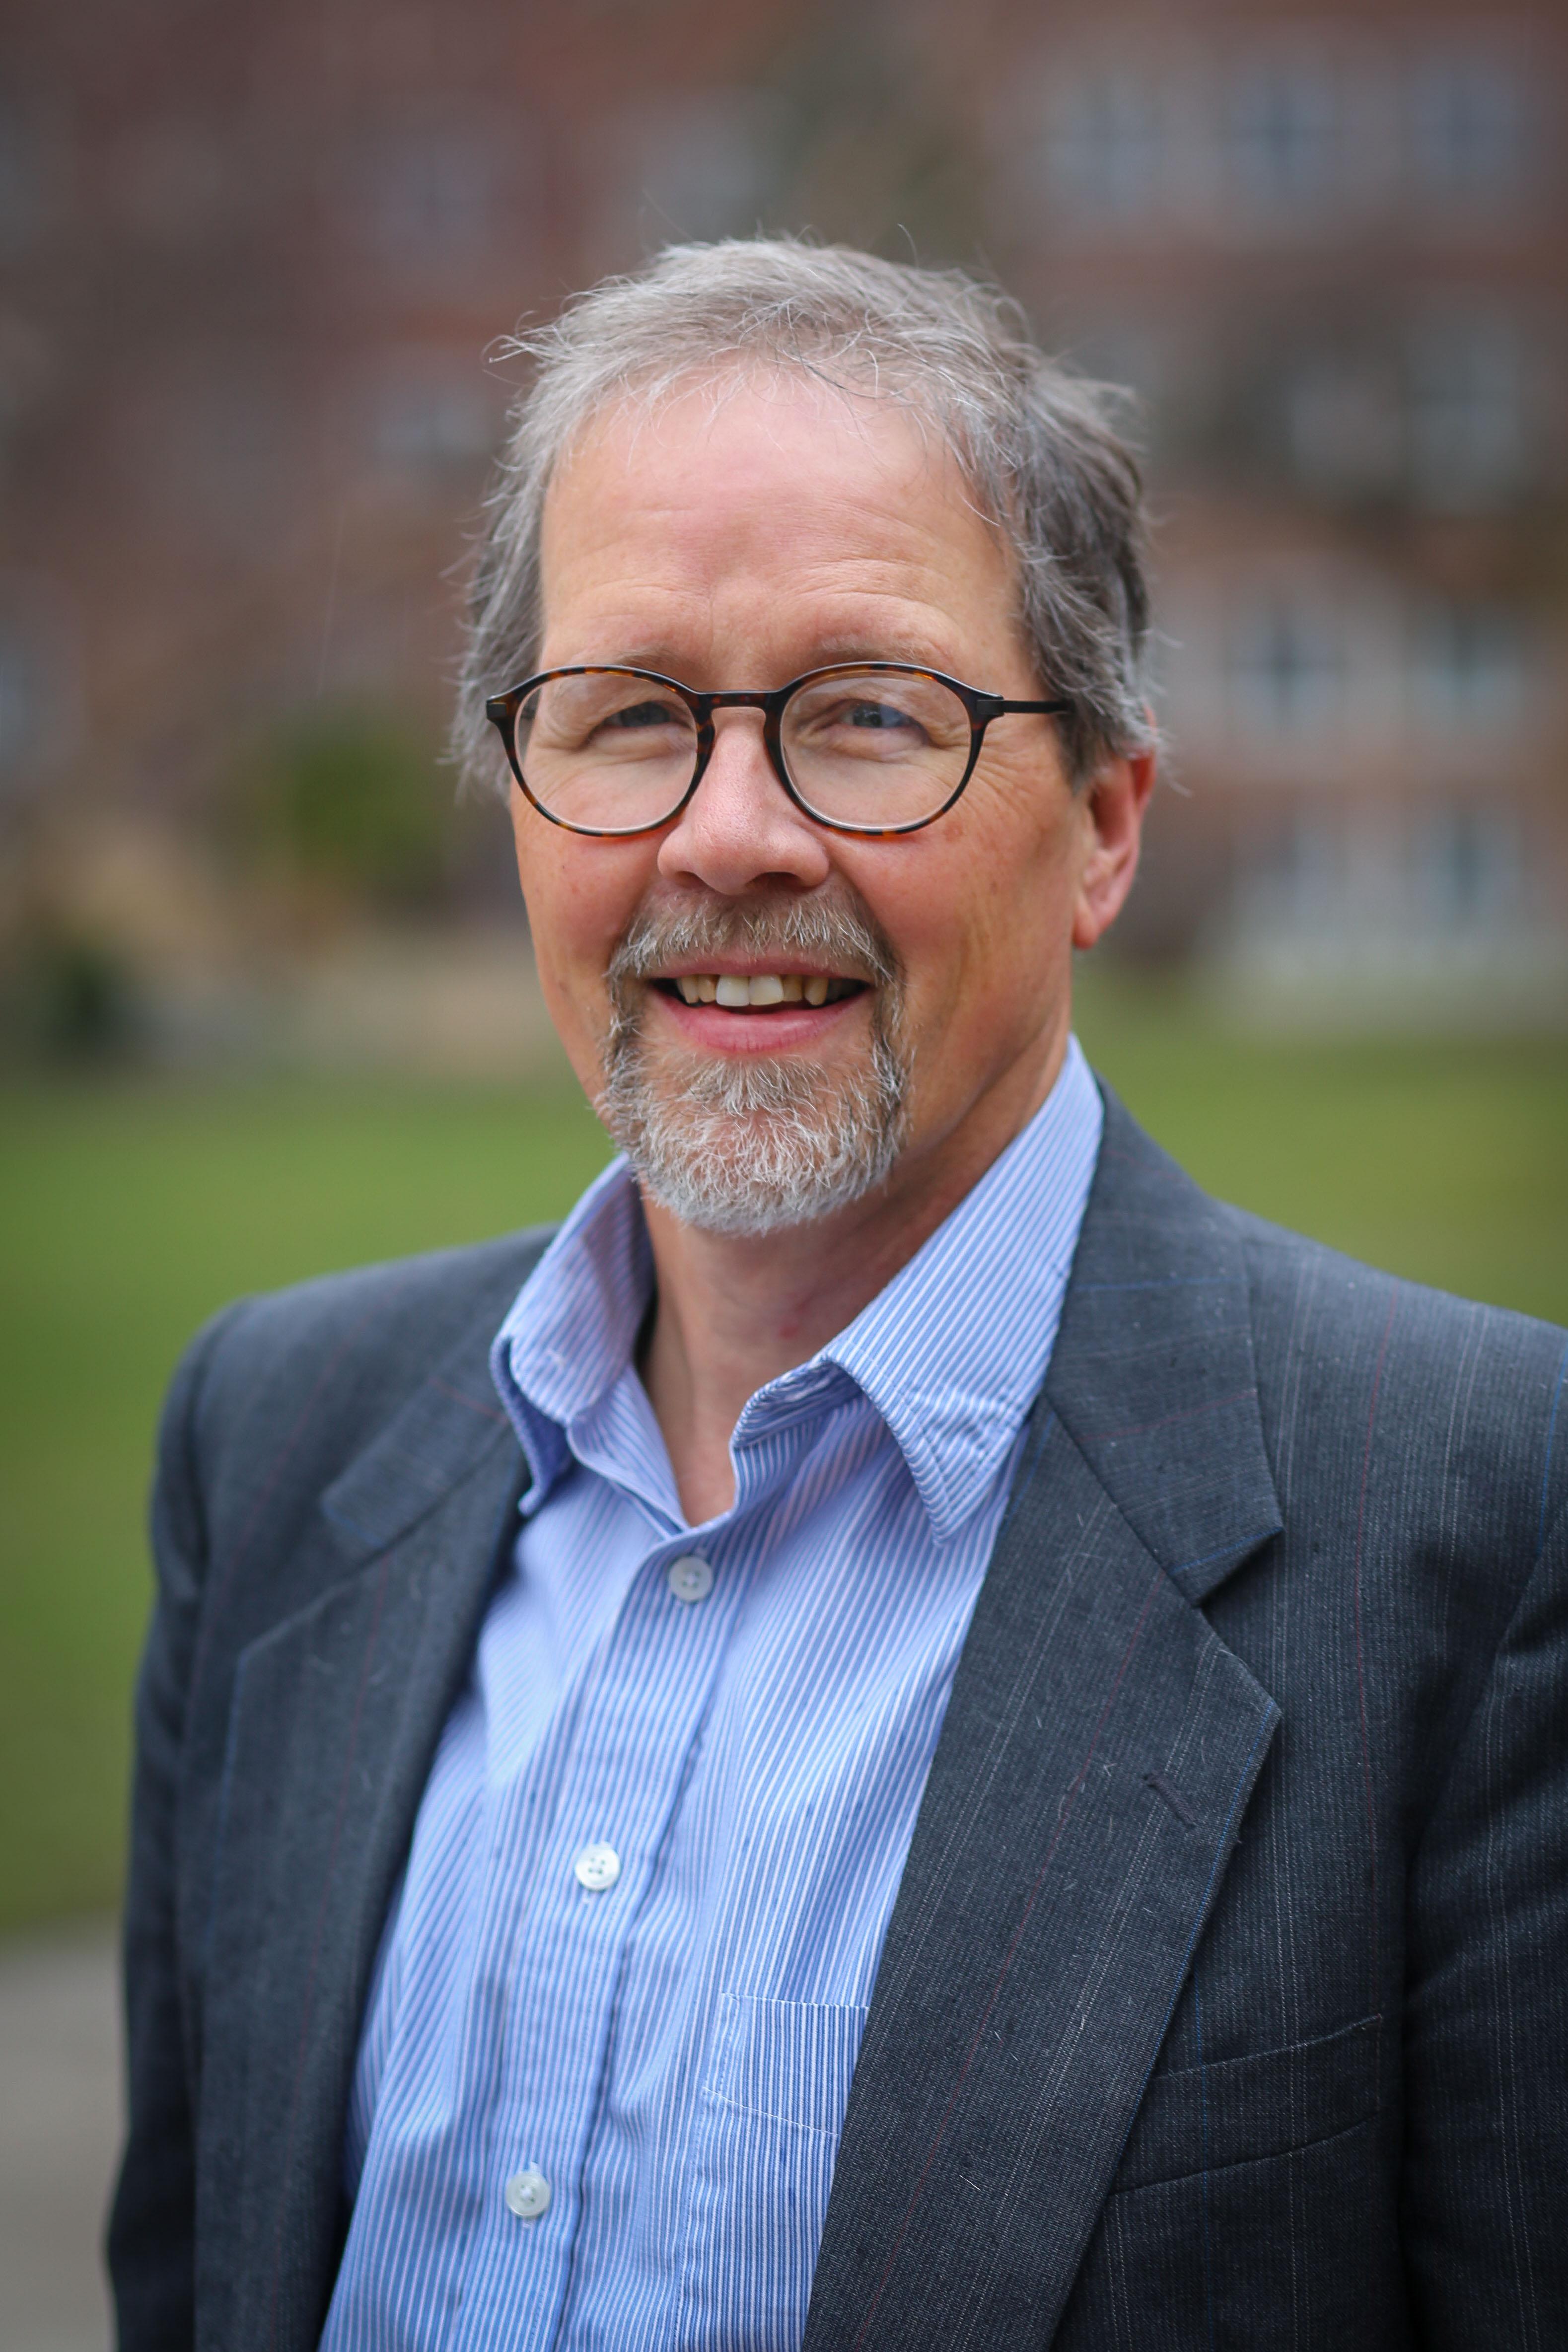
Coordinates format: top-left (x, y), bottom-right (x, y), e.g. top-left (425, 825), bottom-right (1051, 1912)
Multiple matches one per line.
top-left (517, 668), bottom-right (971, 833)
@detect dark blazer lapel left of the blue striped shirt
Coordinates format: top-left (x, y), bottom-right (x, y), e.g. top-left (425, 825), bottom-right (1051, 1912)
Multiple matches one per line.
top-left (198, 1334), bottom-right (522, 2352)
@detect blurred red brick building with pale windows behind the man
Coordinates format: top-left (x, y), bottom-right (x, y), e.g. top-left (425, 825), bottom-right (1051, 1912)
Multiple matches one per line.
top-left (0, 0), bottom-right (1568, 1011)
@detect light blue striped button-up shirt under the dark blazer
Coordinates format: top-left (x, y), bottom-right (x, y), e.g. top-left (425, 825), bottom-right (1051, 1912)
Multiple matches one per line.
top-left (322, 1042), bottom-right (1103, 2352)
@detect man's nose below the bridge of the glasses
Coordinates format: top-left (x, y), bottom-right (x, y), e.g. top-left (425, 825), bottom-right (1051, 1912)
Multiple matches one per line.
top-left (658, 711), bottom-right (832, 899)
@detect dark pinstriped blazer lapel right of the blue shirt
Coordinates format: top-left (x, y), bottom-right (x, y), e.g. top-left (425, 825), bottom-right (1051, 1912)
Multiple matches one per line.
top-left (806, 1101), bottom-right (1279, 2352)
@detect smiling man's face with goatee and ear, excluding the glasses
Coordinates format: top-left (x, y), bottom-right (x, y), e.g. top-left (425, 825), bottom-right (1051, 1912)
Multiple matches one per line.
top-left (512, 381), bottom-right (1147, 1230)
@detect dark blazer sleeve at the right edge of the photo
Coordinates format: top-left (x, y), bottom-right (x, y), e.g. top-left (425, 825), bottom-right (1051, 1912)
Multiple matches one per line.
top-left (1404, 1510), bottom-right (1568, 2352)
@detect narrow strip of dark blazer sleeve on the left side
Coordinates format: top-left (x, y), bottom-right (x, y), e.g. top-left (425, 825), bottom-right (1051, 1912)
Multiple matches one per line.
top-left (108, 1301), bottom-right (244, 2352)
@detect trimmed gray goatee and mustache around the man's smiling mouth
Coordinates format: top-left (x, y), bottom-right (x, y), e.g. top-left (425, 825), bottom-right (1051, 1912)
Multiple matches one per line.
top-left (597, 899), bottom-right (910, 1235)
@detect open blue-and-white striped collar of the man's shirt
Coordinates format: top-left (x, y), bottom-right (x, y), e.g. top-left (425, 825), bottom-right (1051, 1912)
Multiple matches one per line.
top-left (492, 1037), bottom-right (1105, 1541)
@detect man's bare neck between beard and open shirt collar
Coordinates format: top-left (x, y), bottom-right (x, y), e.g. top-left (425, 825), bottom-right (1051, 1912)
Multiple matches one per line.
top-left (642, 1025), bottom-right (1068, 1526)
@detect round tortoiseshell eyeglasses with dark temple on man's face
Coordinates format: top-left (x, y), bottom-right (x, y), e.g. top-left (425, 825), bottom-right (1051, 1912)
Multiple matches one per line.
top-left (484, 661), bottom-right (1072, 840)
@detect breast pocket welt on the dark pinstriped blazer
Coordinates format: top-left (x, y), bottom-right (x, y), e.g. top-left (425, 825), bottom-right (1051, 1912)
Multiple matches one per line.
top-left (1112, 2018), bottom-right (1382, 2192)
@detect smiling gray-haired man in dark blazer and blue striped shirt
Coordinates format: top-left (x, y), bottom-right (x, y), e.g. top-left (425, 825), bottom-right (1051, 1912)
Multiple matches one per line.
top-left (111, 242), bottom-right (1568, 2352)
